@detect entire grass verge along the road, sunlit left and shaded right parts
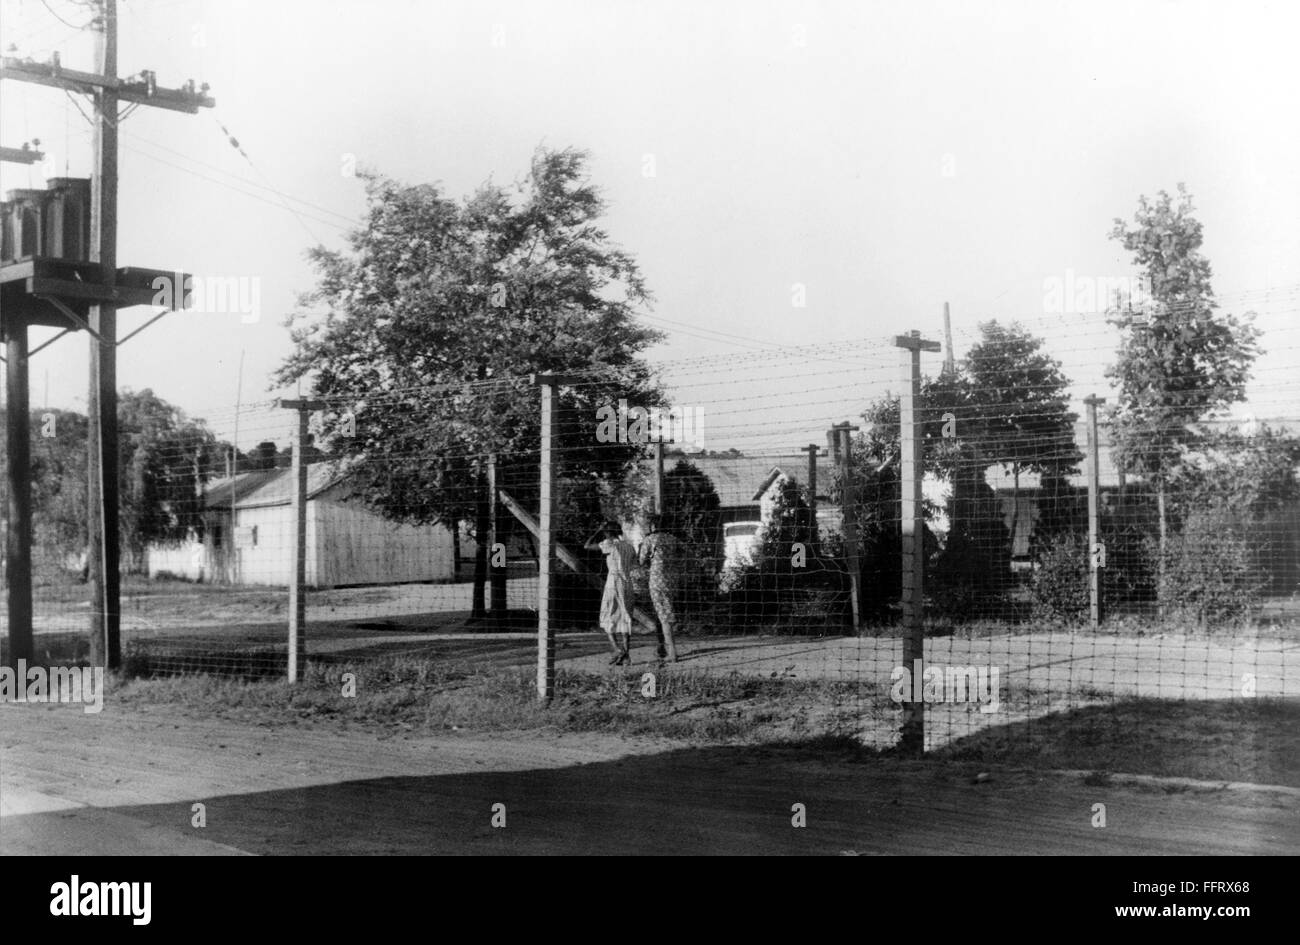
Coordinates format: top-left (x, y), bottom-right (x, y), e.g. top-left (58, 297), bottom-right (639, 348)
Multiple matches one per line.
top-left (91, 655), bottom-right (1300, 788)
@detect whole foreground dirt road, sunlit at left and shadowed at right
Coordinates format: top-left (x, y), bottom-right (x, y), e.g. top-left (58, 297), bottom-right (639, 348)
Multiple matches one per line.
top-left (0, 705), bottom-right (1300, 854)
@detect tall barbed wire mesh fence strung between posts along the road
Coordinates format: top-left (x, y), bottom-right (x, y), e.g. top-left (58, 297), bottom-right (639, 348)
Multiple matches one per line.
top-left (2, 305), bottom-right (1300, 763)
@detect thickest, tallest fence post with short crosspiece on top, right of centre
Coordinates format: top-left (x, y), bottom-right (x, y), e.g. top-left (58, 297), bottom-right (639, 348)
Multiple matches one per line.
top-left (894, 331), bottom-right (940, 757)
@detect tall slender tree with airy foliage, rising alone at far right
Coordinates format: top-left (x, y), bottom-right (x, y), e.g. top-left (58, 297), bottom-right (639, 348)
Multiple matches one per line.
top-left (1106, 185), bottom-right (1258, 558)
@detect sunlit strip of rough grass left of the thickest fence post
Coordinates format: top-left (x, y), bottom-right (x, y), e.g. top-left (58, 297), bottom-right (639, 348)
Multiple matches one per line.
top-left (112, 656), bottom-right (870, 744)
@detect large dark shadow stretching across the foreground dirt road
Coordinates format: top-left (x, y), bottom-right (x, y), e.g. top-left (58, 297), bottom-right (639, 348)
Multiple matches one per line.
top-left (5, 745), bottom-right (1300, 855)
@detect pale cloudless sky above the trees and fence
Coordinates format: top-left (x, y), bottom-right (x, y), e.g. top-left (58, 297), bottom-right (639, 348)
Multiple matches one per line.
top-left (0, 0), bottom-right (1300, 448)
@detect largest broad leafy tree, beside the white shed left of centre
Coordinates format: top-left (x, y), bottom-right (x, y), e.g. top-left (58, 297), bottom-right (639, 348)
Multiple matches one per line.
top-left (276, 148), bottom-right (663, 616)
